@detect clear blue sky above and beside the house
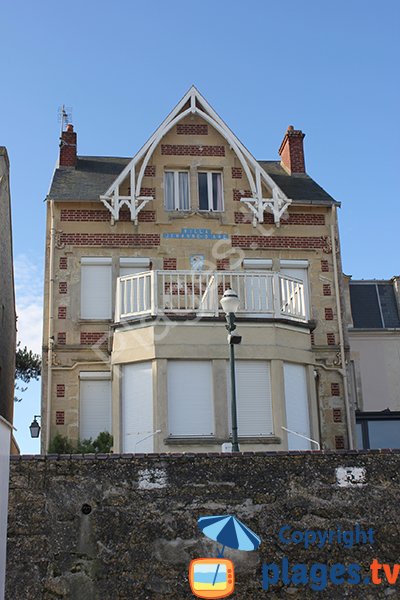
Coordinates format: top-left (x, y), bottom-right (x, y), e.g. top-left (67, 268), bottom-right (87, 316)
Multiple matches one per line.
top-left (0, 0), bottom-right (400, 452)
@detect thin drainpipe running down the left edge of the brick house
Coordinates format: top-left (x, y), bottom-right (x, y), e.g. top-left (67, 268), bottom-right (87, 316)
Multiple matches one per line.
top-left (45, 200), bottom-right (56, 453)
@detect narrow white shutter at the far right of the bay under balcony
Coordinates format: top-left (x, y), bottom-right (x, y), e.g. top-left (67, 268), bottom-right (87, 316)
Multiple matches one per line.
top-left (283, 363), bottom-right (311, 450)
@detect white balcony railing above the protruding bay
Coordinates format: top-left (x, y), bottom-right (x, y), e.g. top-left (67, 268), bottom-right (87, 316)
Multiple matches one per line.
top-left (115, 271), bottom-right (308, 323)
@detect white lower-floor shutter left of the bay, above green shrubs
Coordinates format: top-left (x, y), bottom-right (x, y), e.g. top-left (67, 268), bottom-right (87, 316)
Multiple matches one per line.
top-left (79, 372), bottom-right (112, 440)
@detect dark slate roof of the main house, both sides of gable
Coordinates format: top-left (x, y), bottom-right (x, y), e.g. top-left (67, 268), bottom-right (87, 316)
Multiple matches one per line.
top-left (48, 156), bottom-right (335, 205)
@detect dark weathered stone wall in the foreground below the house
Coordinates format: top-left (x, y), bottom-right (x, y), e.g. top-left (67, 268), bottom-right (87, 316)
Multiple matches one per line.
top-left (6, 451), bottom-right (400, 600)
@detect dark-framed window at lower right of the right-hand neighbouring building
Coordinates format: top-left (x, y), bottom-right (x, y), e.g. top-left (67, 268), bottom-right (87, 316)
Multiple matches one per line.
top-left (356, 411), bottom-right (400, 449)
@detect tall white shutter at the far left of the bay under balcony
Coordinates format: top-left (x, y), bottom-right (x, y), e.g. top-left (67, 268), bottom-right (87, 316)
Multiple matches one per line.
top-left (122, 361), bottom-right (154, 452)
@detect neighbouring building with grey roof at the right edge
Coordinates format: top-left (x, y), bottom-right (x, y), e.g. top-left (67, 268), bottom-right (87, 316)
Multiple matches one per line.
top-left (346, 277), bottom-right (400, 448)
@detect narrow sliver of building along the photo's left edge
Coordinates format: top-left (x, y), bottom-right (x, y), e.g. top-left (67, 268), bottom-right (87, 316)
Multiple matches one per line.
top-left (0, 146), bottom-right (16, 599)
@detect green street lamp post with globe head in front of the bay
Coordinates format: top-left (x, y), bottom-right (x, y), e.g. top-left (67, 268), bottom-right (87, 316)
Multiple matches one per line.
top-left (220, 290), bottom-right (242, 452)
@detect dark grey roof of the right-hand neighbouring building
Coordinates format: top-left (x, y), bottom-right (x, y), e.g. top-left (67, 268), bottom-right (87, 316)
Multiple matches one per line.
top-left (350, 281), bottom-right (400, 329)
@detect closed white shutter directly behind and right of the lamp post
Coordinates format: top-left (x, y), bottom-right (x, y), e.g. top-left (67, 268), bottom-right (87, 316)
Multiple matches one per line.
top-left (228, 360), bottom-right (274, 437)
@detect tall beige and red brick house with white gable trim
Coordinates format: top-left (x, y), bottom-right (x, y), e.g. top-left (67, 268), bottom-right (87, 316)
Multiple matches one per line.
top-left (42, 87), bottom-right (352, 452)
